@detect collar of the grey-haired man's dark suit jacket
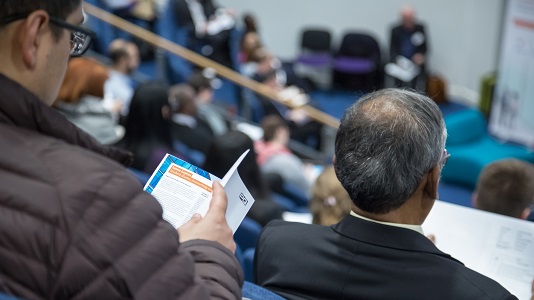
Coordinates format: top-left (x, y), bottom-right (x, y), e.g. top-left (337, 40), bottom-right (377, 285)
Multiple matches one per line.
top-left (332, 215), bottom-right (462, 264)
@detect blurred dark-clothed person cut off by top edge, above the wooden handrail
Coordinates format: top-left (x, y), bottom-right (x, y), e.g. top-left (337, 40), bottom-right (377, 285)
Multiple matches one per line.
top-left (175, 0), bottom-right (235, 68)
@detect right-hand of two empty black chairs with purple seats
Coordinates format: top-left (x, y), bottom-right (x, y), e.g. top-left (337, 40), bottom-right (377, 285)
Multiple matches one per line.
top-left (333, 32), bottom-right (382, 90)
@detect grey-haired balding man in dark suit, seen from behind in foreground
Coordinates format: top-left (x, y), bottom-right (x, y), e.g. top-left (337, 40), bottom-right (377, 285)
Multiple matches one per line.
top-left (255, 89), bottom-right (517, 299)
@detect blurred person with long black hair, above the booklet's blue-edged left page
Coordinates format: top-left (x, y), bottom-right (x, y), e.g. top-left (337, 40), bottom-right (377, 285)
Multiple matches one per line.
top-left (118, 82), bottom-right (177, 174)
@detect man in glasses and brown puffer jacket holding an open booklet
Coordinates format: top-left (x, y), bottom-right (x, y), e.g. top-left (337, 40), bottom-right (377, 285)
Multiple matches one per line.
top-left (0, 0), bottom-right (243, 299)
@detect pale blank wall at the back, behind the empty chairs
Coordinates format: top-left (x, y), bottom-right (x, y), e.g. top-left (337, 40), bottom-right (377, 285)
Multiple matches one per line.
top-left (220, 0), bottom-right (504, 102)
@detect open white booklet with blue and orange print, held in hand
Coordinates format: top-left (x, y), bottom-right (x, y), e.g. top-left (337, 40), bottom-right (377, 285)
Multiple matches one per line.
top-left (144, 150), bottom-right (255, 233)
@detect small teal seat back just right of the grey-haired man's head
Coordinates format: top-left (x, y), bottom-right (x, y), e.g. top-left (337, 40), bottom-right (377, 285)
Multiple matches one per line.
top-left (445, 109), bottom-right (487, 146)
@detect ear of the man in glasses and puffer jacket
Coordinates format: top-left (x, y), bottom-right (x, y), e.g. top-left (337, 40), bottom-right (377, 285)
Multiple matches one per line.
top-left (18, 10), bottom-right (49, 69)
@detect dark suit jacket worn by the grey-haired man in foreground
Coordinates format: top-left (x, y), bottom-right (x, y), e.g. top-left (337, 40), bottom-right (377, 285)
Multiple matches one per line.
top-left (255, 215), bottom-right (517, 299)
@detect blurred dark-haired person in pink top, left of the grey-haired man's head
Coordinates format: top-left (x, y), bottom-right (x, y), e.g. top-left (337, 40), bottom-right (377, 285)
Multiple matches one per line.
top-left (254, 115), bottom-right (311, 195)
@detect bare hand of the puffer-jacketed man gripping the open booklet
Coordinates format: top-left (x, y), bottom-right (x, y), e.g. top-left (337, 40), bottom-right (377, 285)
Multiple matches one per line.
top-left (178, 182), bottom-right (236, 253)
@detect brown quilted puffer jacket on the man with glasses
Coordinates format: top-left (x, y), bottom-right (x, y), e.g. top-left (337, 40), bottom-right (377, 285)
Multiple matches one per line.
top-left (0, 74), bottom-right (243, 299)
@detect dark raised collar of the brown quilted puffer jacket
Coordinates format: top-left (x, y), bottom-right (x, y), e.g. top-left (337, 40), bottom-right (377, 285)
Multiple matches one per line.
top-left (0, 74), bottom-right (133, 166)
